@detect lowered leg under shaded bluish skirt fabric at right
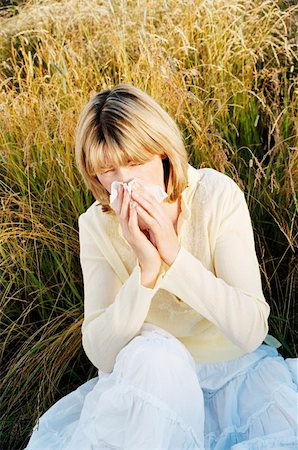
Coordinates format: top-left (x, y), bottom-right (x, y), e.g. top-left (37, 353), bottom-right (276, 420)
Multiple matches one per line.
top-left (197, 345), bottom-right (298, 450)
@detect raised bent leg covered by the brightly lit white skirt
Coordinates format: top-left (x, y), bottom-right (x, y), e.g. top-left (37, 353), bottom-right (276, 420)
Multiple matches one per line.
top-left (73, 327), bottom-right (204, 450)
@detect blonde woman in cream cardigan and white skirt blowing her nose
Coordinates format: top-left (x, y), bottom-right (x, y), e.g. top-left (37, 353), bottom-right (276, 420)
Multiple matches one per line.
top-left (27, 84), bottom-right (297, 450)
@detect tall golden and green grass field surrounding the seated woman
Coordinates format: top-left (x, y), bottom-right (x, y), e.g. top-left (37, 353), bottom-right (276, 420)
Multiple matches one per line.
top-left (0, 0), bottom-right (298, 450)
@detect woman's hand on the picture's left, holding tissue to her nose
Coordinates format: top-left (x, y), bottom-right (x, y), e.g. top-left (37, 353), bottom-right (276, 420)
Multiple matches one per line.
top-left (115, 186), bottom-right (161, 276)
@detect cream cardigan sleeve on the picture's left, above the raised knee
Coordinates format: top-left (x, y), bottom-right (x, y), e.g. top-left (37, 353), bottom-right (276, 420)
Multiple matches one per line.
top-left (79, 214), bottom-right (161, 372)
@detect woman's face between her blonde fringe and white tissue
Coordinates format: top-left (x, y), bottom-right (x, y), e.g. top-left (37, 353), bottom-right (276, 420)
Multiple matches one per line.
top-left (97, 155), bottom-right (165, 193)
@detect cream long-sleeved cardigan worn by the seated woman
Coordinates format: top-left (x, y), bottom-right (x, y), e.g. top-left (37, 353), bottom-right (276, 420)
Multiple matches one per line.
top-left (79, 165), bottom-right (269, 372)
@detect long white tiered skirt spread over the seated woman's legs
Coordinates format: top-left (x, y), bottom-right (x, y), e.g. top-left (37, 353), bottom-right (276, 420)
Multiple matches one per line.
top-left (26, 323), bottom-right (298, 450)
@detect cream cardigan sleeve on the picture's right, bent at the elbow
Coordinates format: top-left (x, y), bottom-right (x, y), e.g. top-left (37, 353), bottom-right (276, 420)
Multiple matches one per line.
top-left (160, 176), bottom-right (269, 352)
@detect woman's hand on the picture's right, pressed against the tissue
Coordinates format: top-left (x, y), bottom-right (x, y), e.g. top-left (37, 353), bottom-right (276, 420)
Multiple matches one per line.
top-left (131, 185), bottom-right (181, 266)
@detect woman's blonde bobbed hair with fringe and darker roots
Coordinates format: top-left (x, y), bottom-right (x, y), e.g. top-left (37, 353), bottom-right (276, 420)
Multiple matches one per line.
top-left (75, 83), bottom-right (188, 214)
